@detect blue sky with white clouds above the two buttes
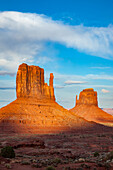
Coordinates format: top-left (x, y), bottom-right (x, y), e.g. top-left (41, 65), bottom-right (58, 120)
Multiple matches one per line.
top-left (0, 0), bottom-right (113, 108)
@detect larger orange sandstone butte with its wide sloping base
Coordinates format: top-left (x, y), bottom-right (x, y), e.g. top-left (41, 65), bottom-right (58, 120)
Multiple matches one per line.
top-left (0, 63), bottom-right (111, 133)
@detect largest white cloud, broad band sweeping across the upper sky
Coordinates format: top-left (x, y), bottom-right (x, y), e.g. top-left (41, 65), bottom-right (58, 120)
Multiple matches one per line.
top-left (0, 12), bottom-right (113, 73)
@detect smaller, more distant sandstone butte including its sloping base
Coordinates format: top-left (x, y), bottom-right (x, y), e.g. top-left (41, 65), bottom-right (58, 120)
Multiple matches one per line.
top-left (70, 88), bottom-right (113, 126)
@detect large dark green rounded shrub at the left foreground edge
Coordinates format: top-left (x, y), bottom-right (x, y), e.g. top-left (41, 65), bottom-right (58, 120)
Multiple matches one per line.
top-left (1, 146), bottom-right (15, 158)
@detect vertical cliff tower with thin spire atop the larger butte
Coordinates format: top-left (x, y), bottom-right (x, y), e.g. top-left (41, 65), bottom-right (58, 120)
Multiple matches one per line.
top-left (16, 63), bottom-right (55, 100)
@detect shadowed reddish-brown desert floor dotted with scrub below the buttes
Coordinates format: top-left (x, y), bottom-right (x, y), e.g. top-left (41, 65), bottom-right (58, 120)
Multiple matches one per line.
top-left (0, 131), bottom-right (113, 170)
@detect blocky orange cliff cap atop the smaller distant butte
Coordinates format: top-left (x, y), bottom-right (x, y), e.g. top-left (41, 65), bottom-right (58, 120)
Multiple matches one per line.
top-left (76, 88), bottom-right (98, 106)
